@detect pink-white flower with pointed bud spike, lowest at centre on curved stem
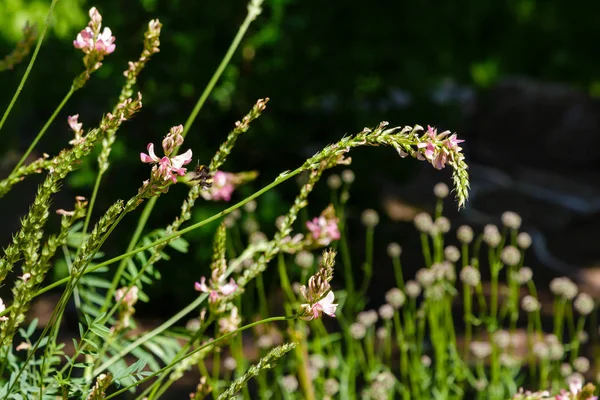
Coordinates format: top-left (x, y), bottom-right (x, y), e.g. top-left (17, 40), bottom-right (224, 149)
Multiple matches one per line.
top-left (299, 250), bottom-right (338, 321)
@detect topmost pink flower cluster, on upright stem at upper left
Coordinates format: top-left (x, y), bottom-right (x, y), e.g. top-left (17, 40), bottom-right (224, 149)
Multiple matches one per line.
top-left (73, 7), bottom-right (115, 83)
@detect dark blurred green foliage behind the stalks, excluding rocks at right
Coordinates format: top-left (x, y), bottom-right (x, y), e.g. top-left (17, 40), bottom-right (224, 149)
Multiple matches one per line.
top-left (0, 0), bottom-right (600, 310)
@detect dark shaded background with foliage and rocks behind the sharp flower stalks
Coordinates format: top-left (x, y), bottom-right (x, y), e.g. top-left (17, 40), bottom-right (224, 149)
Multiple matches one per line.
top-left (0, 0), bottom-right (600, 315)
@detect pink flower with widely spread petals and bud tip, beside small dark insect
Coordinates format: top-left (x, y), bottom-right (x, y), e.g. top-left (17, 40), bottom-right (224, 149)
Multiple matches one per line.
top-left (140, 125), bottom-right (192, 195)
